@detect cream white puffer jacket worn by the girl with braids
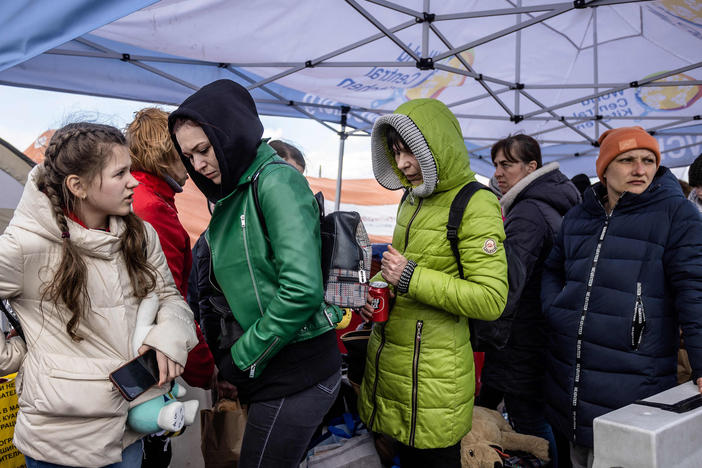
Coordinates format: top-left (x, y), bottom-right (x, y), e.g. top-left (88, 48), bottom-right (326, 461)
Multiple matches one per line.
top-left (0, 168), bottom-right (197, 467)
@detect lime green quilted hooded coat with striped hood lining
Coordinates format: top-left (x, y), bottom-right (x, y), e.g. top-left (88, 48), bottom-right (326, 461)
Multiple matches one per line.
top-left (359, 99), bottom-right (508, 449)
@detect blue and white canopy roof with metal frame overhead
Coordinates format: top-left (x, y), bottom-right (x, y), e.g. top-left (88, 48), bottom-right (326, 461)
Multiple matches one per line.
top-left (0, 0), bottom-right (702, 207)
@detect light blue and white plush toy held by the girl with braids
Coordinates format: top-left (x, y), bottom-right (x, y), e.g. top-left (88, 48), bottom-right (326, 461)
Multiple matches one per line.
top-left (127, 294), bottom-right (199, 435)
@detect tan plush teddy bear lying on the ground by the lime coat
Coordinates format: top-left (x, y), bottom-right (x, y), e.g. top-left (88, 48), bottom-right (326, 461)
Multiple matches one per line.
top-left (461, 406), bottom-right (549, 468)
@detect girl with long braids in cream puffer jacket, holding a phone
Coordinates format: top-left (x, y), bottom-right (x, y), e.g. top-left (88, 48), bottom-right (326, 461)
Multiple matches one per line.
top-left (0, 123), bottom-right (197, 467)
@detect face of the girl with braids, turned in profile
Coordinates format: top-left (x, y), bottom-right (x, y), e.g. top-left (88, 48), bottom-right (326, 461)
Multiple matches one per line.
top-left (79, 145), bottom-right (139, 228)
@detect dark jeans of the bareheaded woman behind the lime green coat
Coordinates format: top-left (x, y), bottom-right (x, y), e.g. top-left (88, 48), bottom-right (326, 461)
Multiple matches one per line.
top-left (477, 385), bottom-right (558, 467)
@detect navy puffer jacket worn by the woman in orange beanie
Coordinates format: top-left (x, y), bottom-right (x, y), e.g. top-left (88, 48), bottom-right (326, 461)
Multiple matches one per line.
top-left (542, 167), bottom-right (702, 447)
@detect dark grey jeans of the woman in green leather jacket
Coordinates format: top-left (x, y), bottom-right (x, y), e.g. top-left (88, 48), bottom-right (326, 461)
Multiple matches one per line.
top-left (239, 371), bottom-right (341, 468)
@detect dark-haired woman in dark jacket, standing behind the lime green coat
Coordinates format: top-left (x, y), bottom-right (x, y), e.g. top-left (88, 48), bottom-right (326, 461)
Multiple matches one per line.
top-left (478, 135), bottom-right (580, 466)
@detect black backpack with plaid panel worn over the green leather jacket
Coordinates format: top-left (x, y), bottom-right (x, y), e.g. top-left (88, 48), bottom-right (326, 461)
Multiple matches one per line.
top-left (251, 161), bottom-right (372, 308)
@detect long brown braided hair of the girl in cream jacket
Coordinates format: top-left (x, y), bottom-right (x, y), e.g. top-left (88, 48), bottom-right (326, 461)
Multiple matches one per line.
top-left (37, 122), bottom-right (156, 341)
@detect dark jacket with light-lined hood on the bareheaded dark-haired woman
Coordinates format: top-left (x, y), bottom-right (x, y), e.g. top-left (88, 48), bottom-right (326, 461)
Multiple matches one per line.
top-left (481, 162), bottom-right (580, 399)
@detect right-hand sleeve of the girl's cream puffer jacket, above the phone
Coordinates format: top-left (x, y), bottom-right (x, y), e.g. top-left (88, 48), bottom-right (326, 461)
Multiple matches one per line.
top-left (144, 222), bottom-right (198, 366)
